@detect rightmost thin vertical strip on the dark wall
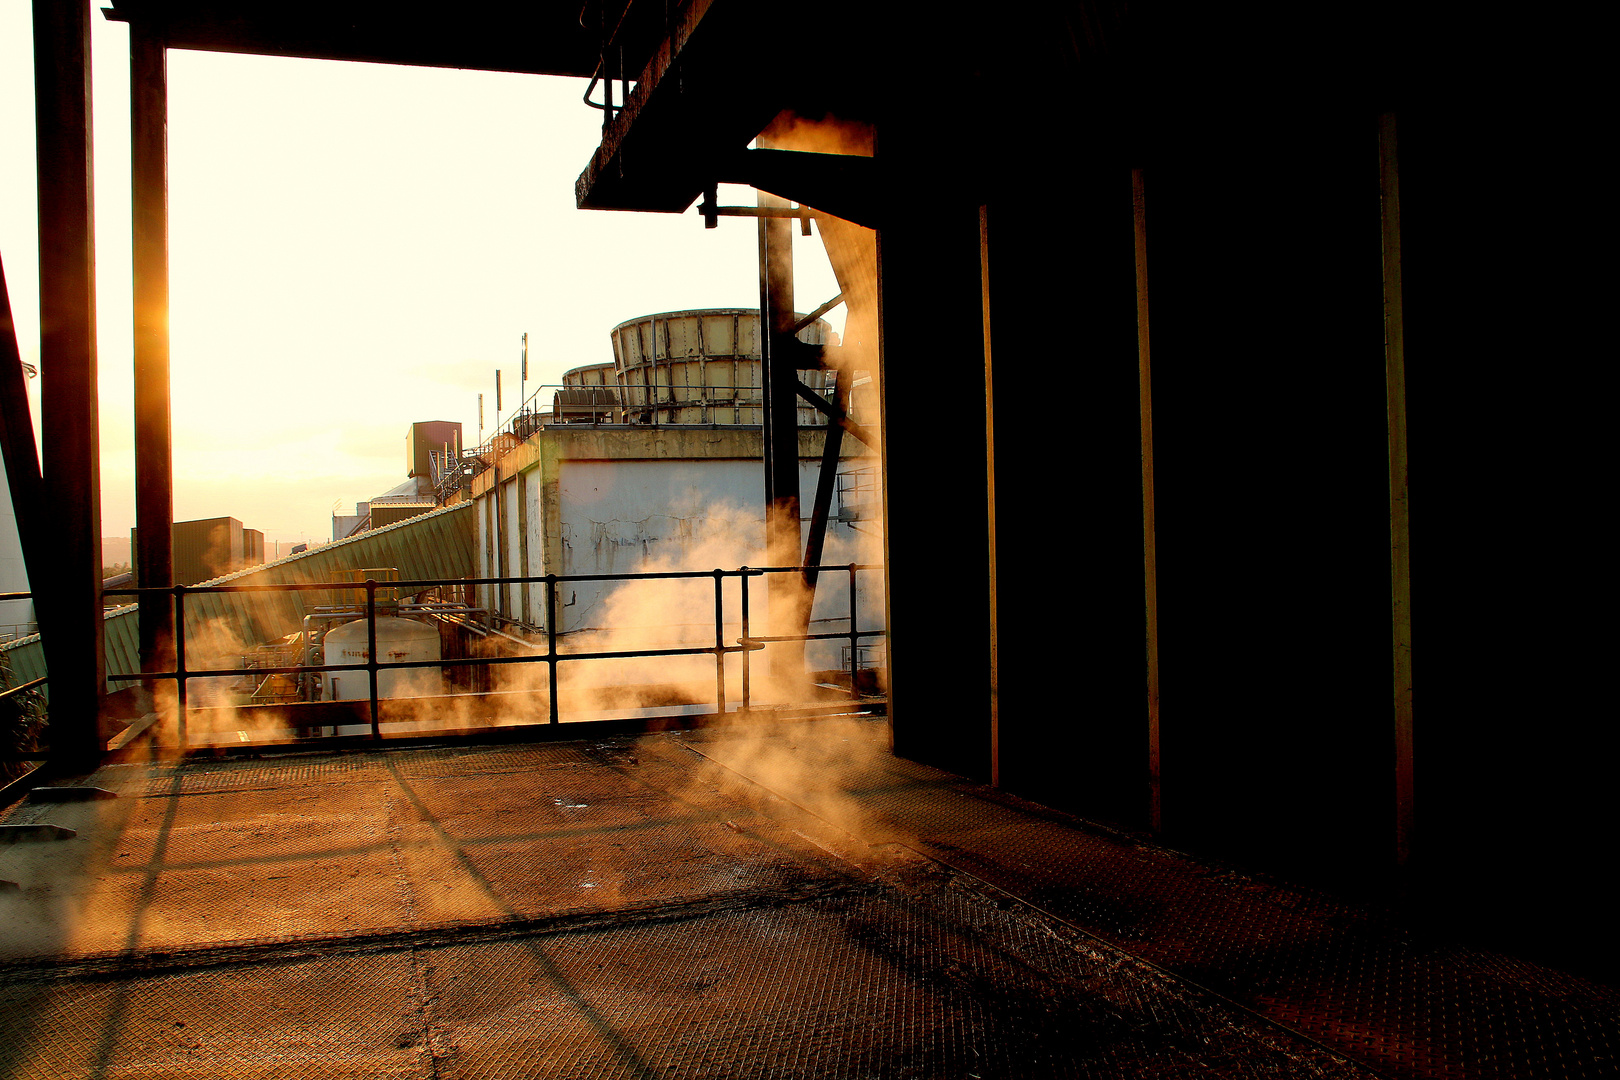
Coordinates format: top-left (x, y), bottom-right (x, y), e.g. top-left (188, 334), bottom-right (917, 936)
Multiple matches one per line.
top-left (1379, 113), bottom-right (1416, 866)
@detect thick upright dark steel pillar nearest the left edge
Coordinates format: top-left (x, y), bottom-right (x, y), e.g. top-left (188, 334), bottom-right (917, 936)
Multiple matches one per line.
top-left (29, 0), bottom-right (105, 764)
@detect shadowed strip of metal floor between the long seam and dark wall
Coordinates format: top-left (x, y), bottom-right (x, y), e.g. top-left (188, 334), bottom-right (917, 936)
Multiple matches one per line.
top-left (684, 718), bottom-right (1620, 1078)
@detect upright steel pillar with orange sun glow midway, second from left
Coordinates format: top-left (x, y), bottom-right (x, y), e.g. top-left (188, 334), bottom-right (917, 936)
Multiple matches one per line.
top-left (130, 21), bottom-right (175, 731)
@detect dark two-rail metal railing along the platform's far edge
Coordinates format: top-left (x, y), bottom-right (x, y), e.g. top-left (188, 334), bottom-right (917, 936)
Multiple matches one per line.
top-left (88, 563), bottom-right (886, 748)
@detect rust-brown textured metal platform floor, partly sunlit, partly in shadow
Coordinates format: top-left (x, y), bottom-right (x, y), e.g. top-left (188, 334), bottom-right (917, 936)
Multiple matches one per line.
top-left (0, 721), bottom-right (1620, 1078)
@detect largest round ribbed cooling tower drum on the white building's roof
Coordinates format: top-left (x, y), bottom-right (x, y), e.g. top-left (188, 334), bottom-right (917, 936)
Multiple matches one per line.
top-left (612, 308), bottom-right (836, 426)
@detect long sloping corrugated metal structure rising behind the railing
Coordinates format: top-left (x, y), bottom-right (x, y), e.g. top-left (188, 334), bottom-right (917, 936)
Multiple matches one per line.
top-left (0, 502), bottom-right (476, 702)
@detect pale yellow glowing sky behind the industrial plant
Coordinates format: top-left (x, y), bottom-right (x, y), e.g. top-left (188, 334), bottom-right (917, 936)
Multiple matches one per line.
top-left (0, 0), bottom-right (844, 541)
